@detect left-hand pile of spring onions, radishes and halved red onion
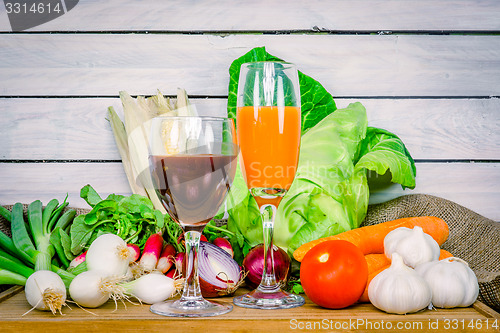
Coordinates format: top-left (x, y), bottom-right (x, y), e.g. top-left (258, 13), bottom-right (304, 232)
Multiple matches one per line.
top-left (0, 185), bottom-right (244, 314)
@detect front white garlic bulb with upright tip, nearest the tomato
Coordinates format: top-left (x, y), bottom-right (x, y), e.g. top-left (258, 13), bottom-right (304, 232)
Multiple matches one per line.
top-left (368, 253), bottom-right (432, 314)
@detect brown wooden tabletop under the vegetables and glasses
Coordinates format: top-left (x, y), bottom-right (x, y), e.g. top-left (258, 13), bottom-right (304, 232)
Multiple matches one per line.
top-left (0, 288), bottom-right (498, 332)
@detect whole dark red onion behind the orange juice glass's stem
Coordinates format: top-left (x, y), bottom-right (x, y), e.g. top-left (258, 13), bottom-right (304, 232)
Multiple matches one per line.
top-left (243, 244), bottom-right (290, 289)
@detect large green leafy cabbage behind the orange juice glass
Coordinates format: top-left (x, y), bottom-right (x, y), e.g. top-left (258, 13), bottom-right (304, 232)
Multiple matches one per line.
top-left (228, 48), bottom-right (416, 253)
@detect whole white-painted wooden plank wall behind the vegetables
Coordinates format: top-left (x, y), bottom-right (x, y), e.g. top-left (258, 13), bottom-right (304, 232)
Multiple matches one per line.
top-left (0, 0), bottom-right (500, 221)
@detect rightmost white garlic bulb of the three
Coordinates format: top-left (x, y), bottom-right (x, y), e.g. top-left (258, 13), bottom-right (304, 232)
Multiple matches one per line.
top-left (415, 257), bottom-right (479, 308)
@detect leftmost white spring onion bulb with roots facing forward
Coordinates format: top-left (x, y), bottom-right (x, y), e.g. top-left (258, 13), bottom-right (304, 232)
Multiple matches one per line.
top-left (24, 270), bottom-right (66, 314)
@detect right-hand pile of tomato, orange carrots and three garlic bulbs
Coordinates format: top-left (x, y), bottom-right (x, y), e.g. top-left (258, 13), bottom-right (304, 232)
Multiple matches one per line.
top-left (294, 216), bottom-right (479, 314)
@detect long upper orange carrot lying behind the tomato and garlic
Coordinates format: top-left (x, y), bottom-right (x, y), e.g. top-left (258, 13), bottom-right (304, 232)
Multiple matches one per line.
top-left (293, 216), bottom-right (449, 262)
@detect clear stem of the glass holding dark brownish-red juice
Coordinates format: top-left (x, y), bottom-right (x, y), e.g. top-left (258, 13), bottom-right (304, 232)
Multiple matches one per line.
top-left (181, 231), bottom-right (203, 302)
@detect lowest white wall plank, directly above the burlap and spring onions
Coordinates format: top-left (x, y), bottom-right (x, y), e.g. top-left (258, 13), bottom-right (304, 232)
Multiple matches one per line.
top-left (0, 163), bottom-right (500, 221)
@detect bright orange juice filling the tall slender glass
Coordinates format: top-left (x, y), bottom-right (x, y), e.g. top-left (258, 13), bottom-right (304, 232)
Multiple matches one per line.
top-left (236, 106), bottom-right (301, 190)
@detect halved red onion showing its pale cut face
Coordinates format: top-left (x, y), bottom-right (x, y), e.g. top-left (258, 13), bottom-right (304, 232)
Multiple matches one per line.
top-left (198, 242), bottom-right (243, 297)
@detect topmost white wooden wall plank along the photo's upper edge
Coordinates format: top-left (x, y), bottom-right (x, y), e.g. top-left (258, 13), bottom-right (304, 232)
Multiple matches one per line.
top-left (0, 0), bottom-right (500, 31)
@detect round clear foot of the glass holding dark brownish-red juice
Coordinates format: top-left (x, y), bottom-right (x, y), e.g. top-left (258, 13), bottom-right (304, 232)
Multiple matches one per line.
top-left (149, 299), bottom-right (233, 317)
